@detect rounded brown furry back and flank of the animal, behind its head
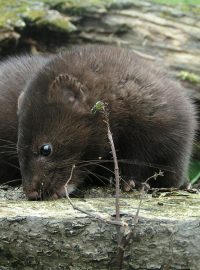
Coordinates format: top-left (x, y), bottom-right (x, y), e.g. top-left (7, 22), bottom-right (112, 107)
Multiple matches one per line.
top-left (59, 46), bottom-right (196, 186)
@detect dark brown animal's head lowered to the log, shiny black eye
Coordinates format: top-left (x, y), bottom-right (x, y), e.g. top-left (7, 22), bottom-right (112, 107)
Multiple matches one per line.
top-left (18, 66), bottom-right (92, 199)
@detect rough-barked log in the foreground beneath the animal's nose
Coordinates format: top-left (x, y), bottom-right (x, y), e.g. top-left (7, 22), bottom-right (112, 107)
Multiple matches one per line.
top-left (0, 191), bottom-right (200, 270)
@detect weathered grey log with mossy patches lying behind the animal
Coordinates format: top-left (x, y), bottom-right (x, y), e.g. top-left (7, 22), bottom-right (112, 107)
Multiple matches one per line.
top-left (0, 0), bottom-right (200, 95)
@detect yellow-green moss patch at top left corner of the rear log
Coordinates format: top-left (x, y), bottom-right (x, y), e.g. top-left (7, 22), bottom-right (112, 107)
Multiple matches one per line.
top-left (0, 0), bottom-right (79, 32)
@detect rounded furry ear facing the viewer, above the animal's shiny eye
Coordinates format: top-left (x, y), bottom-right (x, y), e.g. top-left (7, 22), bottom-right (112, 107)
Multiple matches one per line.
top-left (49, 74), bottom-right (87, 112)
